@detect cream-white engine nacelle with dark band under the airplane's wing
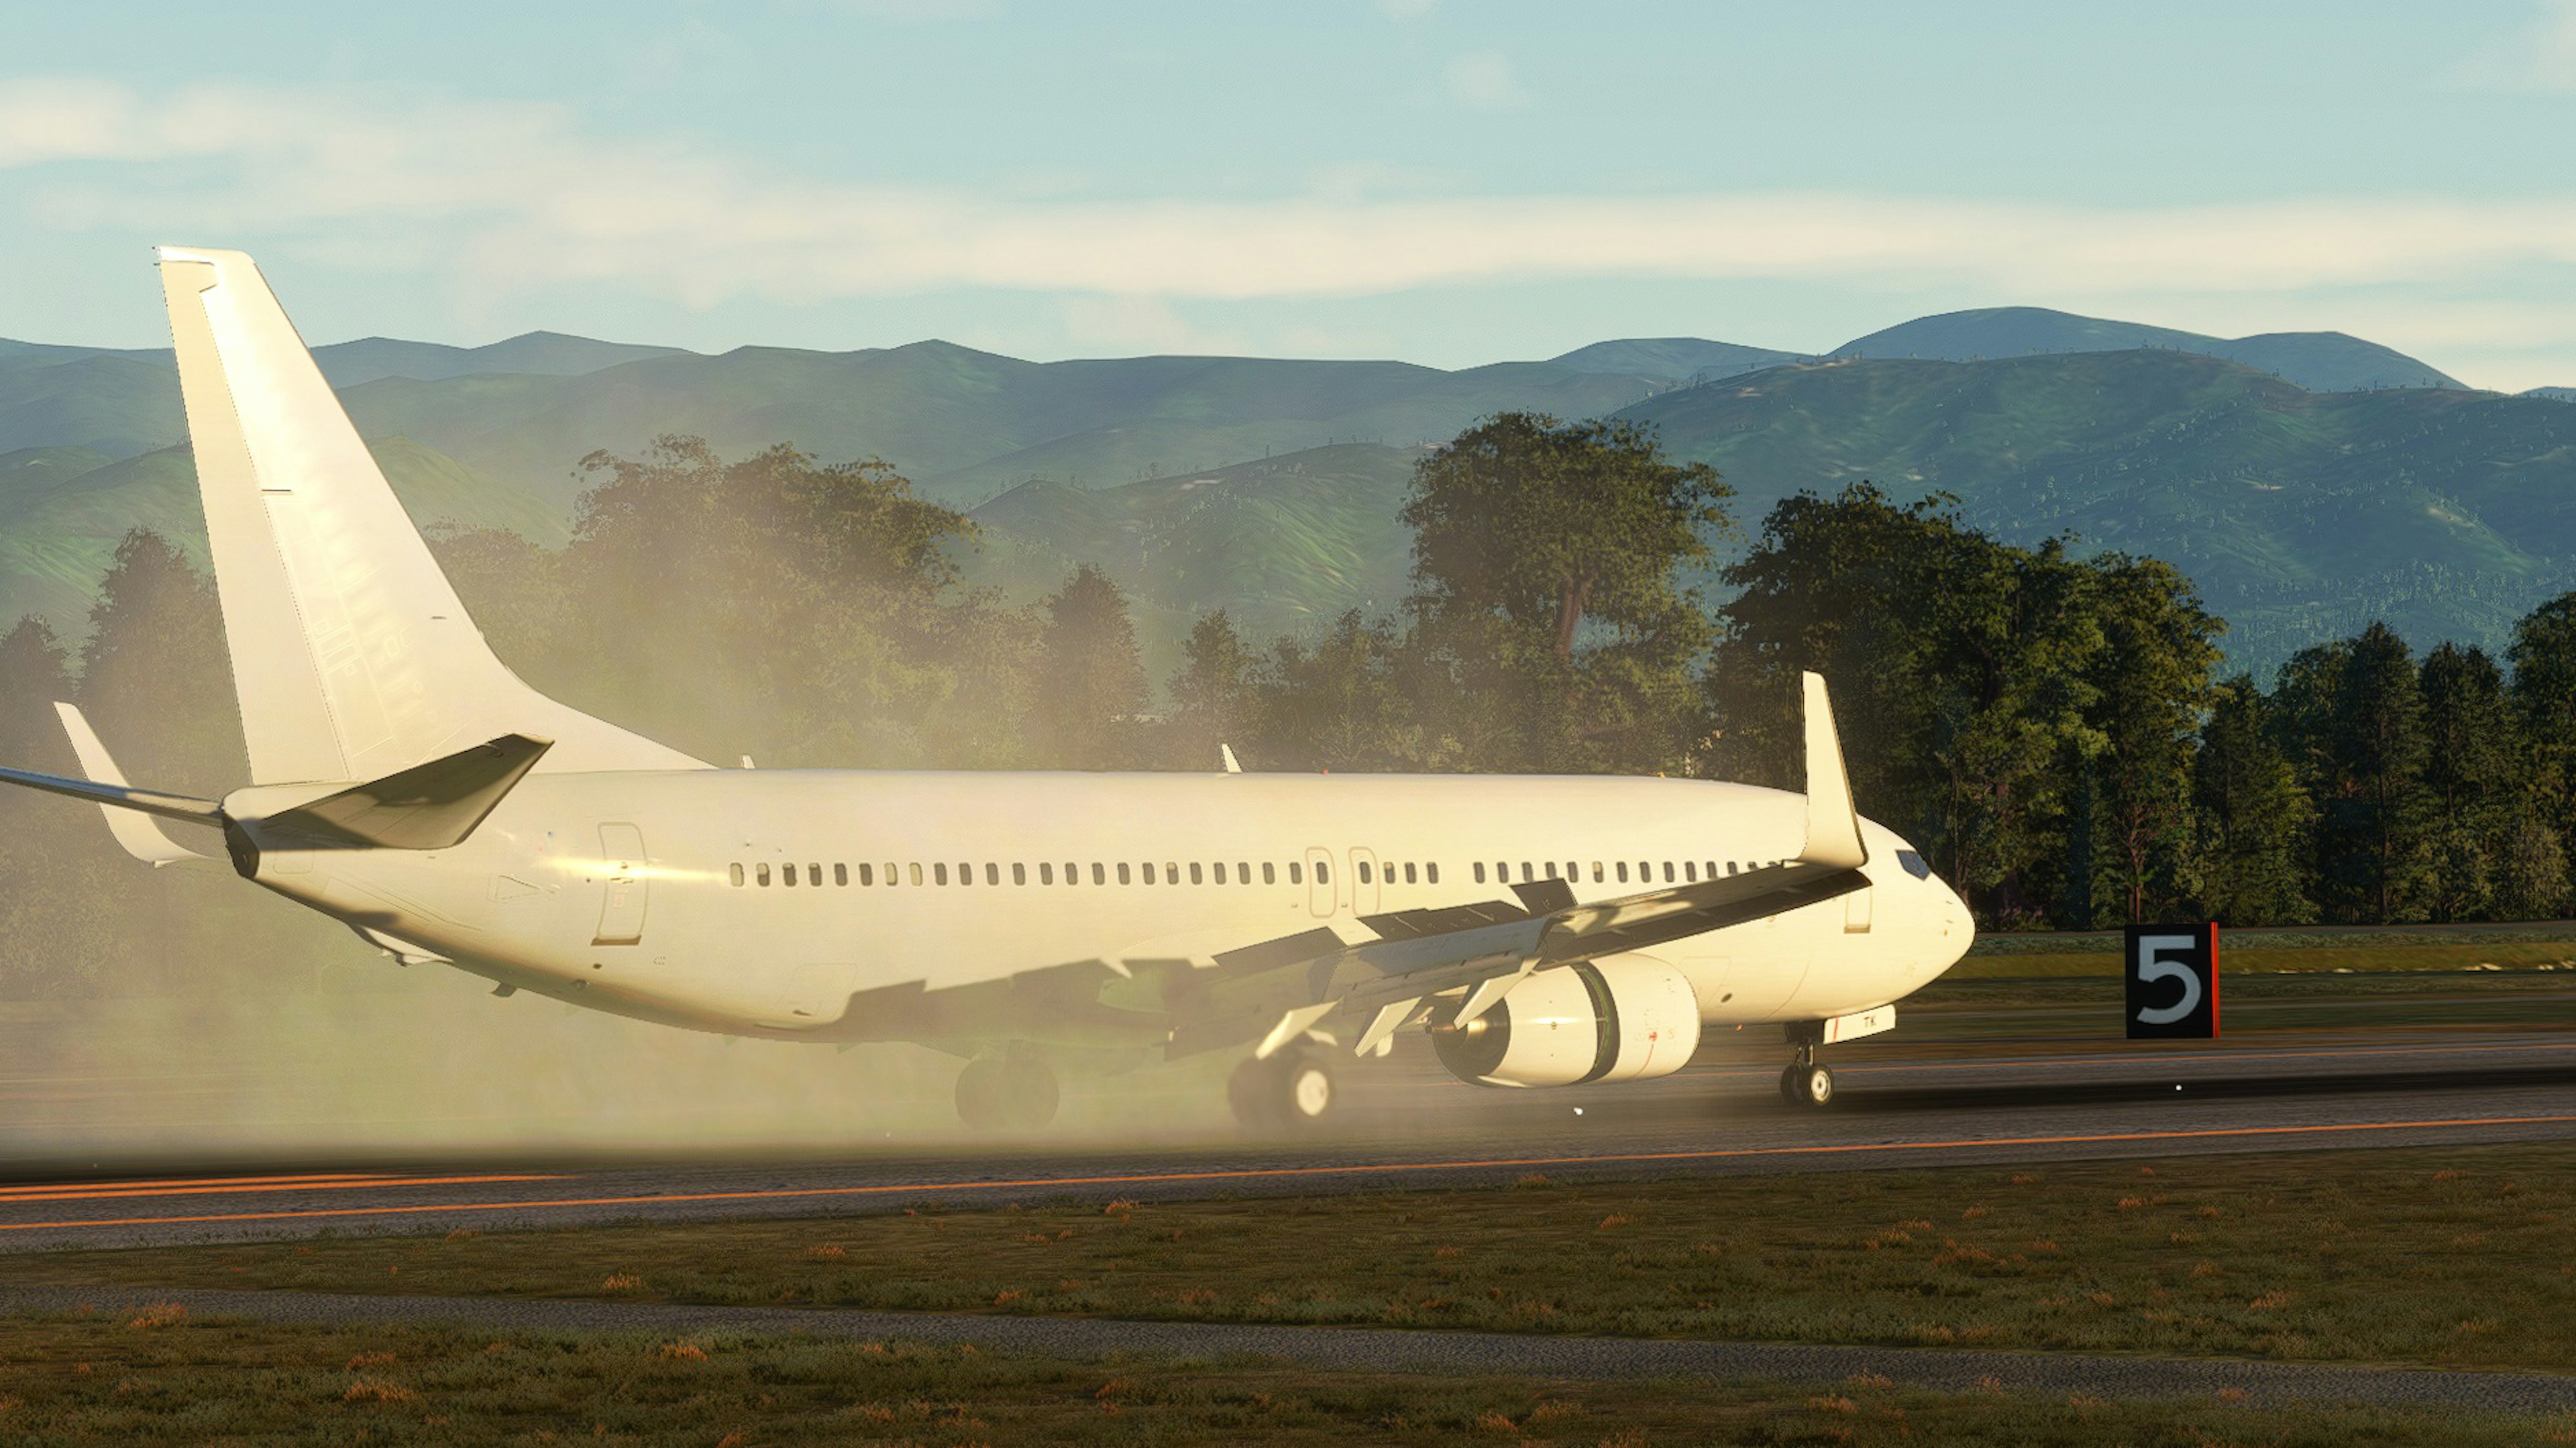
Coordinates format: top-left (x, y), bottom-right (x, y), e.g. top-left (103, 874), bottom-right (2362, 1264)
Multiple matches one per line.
top-left (1432, 956), bottom-right (1700, 1087)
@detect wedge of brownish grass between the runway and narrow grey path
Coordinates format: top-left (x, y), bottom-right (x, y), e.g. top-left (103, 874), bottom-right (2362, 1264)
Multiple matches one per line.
top-left (0, 1147), bottom-right (2576, 1371)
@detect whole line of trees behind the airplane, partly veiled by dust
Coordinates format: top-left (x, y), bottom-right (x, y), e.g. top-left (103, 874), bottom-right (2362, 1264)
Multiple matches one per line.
top-left (0, 412), bottom-right (2576, 995)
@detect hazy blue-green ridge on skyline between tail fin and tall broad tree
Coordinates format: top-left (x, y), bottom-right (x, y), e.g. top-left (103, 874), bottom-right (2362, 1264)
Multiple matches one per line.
top-left (345, 343), bottom-right (1656, 508)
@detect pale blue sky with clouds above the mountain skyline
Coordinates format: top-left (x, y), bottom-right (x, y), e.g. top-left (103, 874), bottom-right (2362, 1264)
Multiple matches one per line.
top-left (0, 0), bottom-right (2576, 389)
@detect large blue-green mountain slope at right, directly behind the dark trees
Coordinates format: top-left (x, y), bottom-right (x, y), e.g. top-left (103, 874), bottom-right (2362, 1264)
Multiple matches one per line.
top-left (1620, 350), bottom-right (2576, 667)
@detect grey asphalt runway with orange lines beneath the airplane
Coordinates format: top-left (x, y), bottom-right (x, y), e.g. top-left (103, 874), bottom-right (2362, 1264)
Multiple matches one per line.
top-left (0, 1028), bottom-right (2576, 1252)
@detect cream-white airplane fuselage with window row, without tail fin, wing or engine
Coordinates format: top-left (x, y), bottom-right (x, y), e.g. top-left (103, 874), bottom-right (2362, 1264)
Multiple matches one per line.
top-left (227, 771), bottom-right (1973, 1041)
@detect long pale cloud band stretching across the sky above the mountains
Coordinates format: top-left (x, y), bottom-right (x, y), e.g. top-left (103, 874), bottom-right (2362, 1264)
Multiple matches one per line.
top-left (0, 80), bottom-right (2576, 325)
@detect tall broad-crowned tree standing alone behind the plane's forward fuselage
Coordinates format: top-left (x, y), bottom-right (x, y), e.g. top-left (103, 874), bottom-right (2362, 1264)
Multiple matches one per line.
top-left (1401, 412), bottom-right (1733, 771)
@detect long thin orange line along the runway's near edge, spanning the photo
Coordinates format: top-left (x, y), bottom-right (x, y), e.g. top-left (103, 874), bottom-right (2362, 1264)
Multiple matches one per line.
top-left (0, 1115), bottom-right (2576, 1231)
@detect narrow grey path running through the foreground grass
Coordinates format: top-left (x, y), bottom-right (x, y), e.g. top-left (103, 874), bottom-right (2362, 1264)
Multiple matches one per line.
top-left (0, 1288), bottom-right (2576, 1414)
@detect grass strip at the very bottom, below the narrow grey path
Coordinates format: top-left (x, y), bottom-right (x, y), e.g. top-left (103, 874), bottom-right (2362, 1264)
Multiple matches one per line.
top-left (0, 1309), bottom-right (2576, 1448)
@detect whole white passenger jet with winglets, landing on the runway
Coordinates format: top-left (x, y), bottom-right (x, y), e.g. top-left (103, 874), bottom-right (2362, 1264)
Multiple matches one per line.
top-left (0, 247), bottom-right (1973, 1129)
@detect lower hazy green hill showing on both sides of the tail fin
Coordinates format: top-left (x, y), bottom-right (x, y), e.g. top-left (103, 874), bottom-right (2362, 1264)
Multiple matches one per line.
top-left (0, 438), bottom-right (567, 639)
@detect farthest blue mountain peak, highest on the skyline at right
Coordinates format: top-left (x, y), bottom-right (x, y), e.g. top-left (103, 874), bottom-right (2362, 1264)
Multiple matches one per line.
top-left (1834, 307), bottom-right (2463, 392)
